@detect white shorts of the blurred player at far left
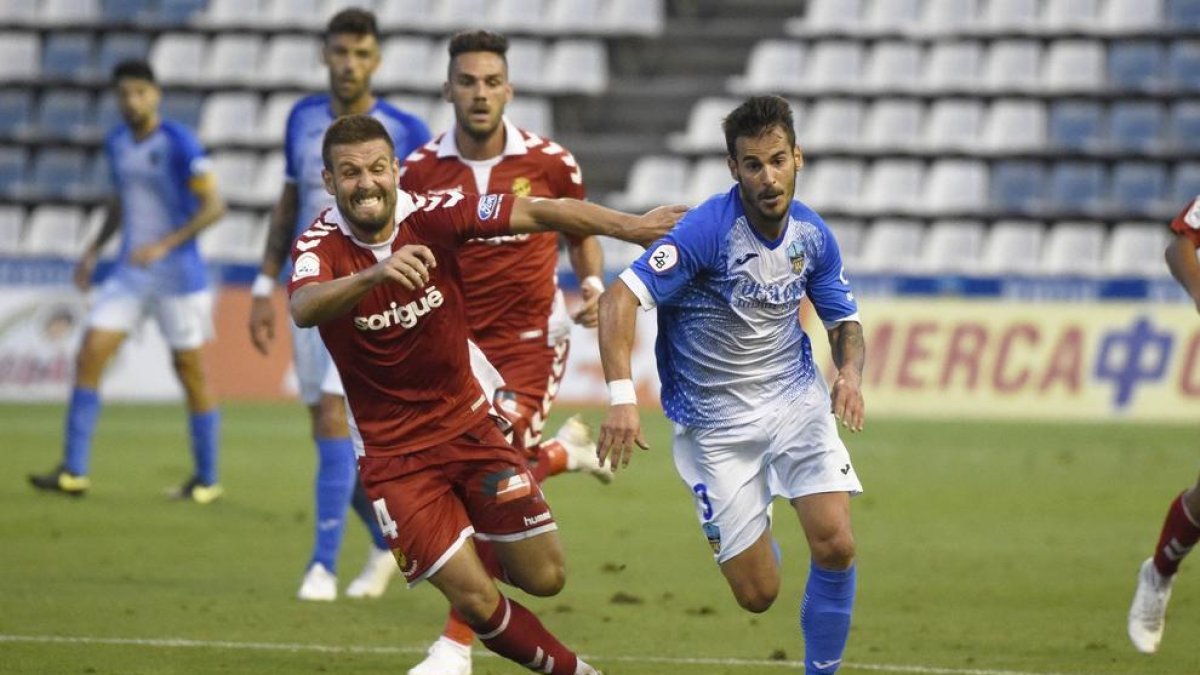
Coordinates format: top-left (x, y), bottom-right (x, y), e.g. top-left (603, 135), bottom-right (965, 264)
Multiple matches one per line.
top-left (88, 275), bottom-right (212, 352)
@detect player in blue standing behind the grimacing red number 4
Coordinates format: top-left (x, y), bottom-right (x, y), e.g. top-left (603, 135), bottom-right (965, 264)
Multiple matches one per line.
top-left (243, 8), bottom-right (431, 601)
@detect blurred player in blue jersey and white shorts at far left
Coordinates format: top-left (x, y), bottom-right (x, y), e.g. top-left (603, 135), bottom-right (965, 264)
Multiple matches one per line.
top-left (29, 61), bottom-right (226, 503)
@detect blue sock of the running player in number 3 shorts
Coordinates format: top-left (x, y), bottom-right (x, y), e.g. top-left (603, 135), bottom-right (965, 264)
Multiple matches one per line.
top-left (800, 563), bottom-right (856, 675)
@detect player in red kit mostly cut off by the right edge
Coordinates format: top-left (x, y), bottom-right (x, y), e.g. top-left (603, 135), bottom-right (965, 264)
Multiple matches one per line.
top-left (1129, 198), bottom-right (1200, 653)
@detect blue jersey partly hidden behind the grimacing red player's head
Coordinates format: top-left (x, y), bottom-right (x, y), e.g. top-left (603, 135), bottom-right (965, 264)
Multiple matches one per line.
top-left (283, 94), bottom-right (431, 239)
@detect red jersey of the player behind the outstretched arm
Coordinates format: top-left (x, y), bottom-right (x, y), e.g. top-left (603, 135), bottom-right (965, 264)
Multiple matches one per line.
top-left (400, 120), bottom-right (584, 346)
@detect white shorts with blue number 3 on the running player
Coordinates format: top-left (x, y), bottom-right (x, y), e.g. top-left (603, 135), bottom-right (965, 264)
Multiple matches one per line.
top-left (673, 386), bottom-right (863, 563)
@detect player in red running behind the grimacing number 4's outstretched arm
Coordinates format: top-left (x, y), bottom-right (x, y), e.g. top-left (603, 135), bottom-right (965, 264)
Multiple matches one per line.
top-left (400, 30), bottom-right (612, 675)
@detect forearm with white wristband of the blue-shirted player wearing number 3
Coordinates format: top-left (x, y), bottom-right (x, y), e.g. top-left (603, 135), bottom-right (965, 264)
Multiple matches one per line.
top-left (596, 281), bottom-right (649, 471)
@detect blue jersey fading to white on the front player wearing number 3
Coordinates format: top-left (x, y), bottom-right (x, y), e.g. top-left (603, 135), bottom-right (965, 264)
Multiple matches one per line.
top-left (620, 185), bottom-right (858, 428)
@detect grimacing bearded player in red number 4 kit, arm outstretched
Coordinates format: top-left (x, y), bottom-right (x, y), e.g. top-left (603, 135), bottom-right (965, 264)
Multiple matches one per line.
top-left (288, 115), bottom-right (684, 675)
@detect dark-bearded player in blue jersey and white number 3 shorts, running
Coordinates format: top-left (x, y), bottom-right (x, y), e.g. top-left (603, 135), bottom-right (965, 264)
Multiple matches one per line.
top-left (598, 96), bottom-right (864, 674)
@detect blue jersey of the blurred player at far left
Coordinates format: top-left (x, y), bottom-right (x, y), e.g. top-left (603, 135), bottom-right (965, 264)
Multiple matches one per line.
top-left (104, 120), bottom-right (211, 295)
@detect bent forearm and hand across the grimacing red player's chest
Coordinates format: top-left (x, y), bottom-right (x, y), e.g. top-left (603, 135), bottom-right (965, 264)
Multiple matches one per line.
top-left (289, 244), bottom-right (437, 328)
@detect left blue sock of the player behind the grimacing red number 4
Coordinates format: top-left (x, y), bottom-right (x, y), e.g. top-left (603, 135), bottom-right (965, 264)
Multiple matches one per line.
top-left (308, 437), bottom-right (358, 572)
